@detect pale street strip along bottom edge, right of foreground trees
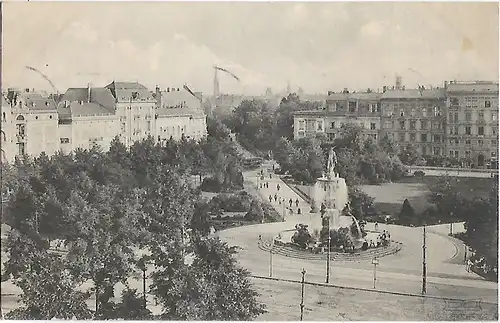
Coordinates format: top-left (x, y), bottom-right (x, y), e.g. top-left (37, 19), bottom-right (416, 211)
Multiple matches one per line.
top-left (252, 279), bottom-right (498, 321)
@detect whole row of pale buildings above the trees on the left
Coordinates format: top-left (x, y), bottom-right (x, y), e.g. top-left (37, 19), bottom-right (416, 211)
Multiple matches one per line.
top-left (0, 82), bottom-right (207, 162)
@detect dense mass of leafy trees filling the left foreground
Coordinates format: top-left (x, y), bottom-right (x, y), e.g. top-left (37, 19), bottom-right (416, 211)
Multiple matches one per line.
top-left (2, 132), bottom-right (263, 320)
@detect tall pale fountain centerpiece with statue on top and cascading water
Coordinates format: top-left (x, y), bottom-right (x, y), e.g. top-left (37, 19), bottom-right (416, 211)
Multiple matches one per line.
top-left (311, 147), bottom-right (365, 249)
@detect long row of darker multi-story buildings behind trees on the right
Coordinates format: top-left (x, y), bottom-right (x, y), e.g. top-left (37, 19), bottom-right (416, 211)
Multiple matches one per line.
top-left (294, 81), bottom-right (499, 168)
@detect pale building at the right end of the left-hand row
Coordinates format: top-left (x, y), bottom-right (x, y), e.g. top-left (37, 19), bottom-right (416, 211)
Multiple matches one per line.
top-left (155, 87), bottom-right (207, 143)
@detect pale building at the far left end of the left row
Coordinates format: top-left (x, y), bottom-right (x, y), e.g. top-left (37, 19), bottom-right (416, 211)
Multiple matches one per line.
top-left (2, 89), bottom-right (59, 162)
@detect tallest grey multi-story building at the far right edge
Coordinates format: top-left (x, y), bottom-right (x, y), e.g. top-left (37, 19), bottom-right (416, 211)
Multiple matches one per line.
top-left (445, 81), bottom-right (499, 168)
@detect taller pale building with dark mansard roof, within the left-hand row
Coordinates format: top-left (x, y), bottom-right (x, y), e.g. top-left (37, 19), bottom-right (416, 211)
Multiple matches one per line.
top-left (105, 82), bottom-right (156, 147)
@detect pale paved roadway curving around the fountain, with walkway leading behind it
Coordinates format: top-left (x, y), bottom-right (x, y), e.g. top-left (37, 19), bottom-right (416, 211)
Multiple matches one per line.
top-left (219, 164), bottom-right (498, 302)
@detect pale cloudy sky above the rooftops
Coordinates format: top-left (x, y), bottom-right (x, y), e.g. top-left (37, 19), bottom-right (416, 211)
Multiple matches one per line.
top-left (2, 2), bottom-right (499, 94)
